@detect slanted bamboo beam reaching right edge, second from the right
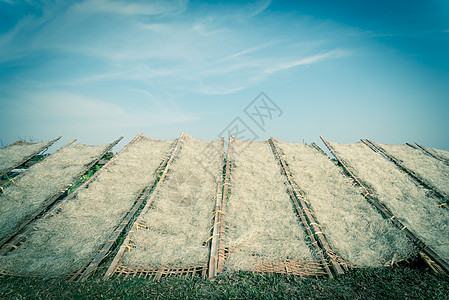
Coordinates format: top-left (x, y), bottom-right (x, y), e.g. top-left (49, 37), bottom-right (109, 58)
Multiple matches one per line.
top-left (361, 139), bottom-right (449, 209)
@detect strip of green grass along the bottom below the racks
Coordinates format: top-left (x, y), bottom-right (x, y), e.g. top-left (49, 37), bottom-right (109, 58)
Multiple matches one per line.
top-left (0, 265), bottom-right (449, 299)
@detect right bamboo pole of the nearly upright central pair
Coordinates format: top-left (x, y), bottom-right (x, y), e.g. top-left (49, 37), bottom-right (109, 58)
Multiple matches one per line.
top-left (217, 136), bottom-right (235, 273)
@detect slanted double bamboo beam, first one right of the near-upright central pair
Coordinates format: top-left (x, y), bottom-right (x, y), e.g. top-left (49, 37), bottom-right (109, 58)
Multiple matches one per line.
top-left (268, 138), bottom-right (344, 278)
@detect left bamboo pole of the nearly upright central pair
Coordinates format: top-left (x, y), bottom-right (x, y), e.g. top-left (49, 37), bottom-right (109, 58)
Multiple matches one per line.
top-left (209, 138), bottom-right (225, 278)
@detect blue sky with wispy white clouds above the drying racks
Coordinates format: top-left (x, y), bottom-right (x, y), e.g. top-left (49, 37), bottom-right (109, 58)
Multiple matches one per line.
top-left (0, 0), bottom-right (449, 149)
